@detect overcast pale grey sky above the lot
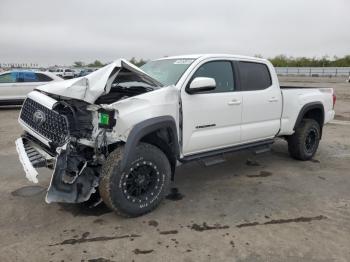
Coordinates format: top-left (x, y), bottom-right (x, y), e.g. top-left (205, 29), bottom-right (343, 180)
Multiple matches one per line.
top-left (0, 0), bottom-right (350, 65)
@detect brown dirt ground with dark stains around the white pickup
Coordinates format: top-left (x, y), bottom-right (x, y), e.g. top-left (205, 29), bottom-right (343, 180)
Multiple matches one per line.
top-left (0, 78), bottom-right (350, 262)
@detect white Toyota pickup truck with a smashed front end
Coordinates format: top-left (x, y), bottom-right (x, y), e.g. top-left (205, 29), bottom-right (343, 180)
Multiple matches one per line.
top-left (16, 55), bottom-right (335, 217)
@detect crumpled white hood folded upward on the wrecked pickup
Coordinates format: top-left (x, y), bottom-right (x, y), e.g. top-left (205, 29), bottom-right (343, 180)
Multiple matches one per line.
top-left (36, 59), bottom-right (162, 104)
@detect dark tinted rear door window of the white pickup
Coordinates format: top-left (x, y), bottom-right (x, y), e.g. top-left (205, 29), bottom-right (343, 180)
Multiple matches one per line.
top-left (238, 61), bottom-right (272, 91)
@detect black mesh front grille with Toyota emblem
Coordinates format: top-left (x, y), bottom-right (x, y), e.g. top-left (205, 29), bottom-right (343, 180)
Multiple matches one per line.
top-left (20, 98), bottom-right (69, 146)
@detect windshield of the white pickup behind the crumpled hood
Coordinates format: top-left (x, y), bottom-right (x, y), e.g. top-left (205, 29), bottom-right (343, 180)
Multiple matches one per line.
top-left (141, 58), bottom-right (194, 86)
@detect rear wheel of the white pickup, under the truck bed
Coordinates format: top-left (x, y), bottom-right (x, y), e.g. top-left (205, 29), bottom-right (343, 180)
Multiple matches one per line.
top-left (288, 119), bottom-right (321, 161)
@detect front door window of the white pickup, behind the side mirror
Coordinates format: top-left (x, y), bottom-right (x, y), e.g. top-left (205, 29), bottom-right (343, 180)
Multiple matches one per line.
top-left (192, 61), bottom-right (235, 93)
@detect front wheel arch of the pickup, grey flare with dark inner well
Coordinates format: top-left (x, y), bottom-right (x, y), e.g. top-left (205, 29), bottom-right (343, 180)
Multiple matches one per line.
top-left (121, 116), bottom-right (180, 176)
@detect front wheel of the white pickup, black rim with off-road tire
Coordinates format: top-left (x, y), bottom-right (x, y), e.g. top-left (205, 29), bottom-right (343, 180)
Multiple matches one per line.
top-left (99, 143), bottom-right (171, 217)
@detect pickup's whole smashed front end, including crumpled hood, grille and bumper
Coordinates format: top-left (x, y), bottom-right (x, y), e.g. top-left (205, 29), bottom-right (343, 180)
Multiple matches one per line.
top-left (16, 59), bottom-right (161, 203)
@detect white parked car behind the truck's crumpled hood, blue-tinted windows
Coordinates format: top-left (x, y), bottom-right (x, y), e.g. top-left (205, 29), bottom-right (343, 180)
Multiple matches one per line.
top-left (0, 71), bottom-right (63, 105)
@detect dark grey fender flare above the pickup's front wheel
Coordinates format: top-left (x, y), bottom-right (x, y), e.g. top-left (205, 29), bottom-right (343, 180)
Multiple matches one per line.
top-left (121, 116), bottom-right (180, 170)
